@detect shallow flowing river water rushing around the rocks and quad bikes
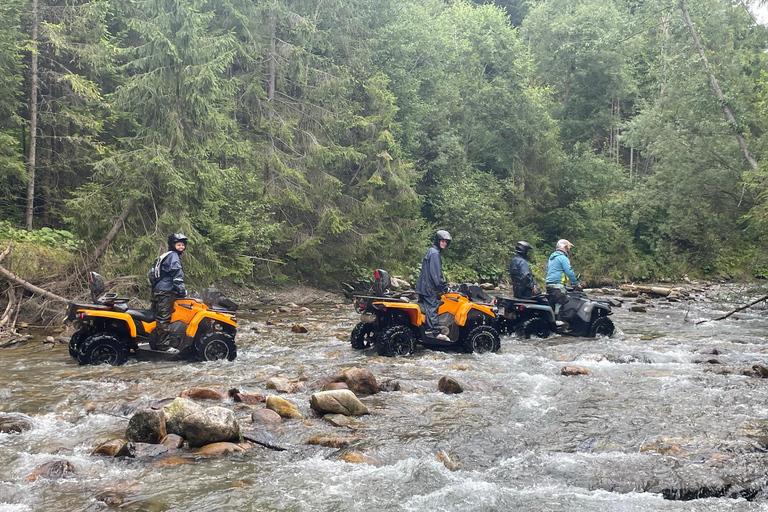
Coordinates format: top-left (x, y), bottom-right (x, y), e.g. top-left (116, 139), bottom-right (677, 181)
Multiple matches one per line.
top-left (0, 287), bottom-right (768, 512)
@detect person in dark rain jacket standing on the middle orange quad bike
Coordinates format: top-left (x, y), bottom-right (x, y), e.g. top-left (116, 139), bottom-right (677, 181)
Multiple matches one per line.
top-left (416, 229), bottom-right (451, 341)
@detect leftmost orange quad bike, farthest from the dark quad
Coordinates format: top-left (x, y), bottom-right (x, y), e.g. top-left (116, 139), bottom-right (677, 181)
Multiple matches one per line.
top-left (66, 272), bottom-right (237, 366)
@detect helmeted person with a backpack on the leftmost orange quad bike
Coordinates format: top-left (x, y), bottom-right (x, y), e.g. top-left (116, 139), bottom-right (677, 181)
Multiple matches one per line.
top-left (147, 233), bottom-right (187, 352)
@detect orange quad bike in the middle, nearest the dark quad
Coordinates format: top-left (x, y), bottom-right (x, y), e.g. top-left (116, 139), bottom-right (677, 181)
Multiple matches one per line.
top-left (350, 269), bottom-right (501, 356)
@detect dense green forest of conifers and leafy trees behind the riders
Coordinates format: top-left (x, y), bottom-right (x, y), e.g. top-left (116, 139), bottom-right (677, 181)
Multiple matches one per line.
top-left (0, 0), bottom-right (768, 285)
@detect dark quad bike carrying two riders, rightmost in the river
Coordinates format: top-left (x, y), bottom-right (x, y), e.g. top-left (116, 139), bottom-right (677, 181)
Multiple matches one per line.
top-left (496, 290), bottom-right (615, 339)
